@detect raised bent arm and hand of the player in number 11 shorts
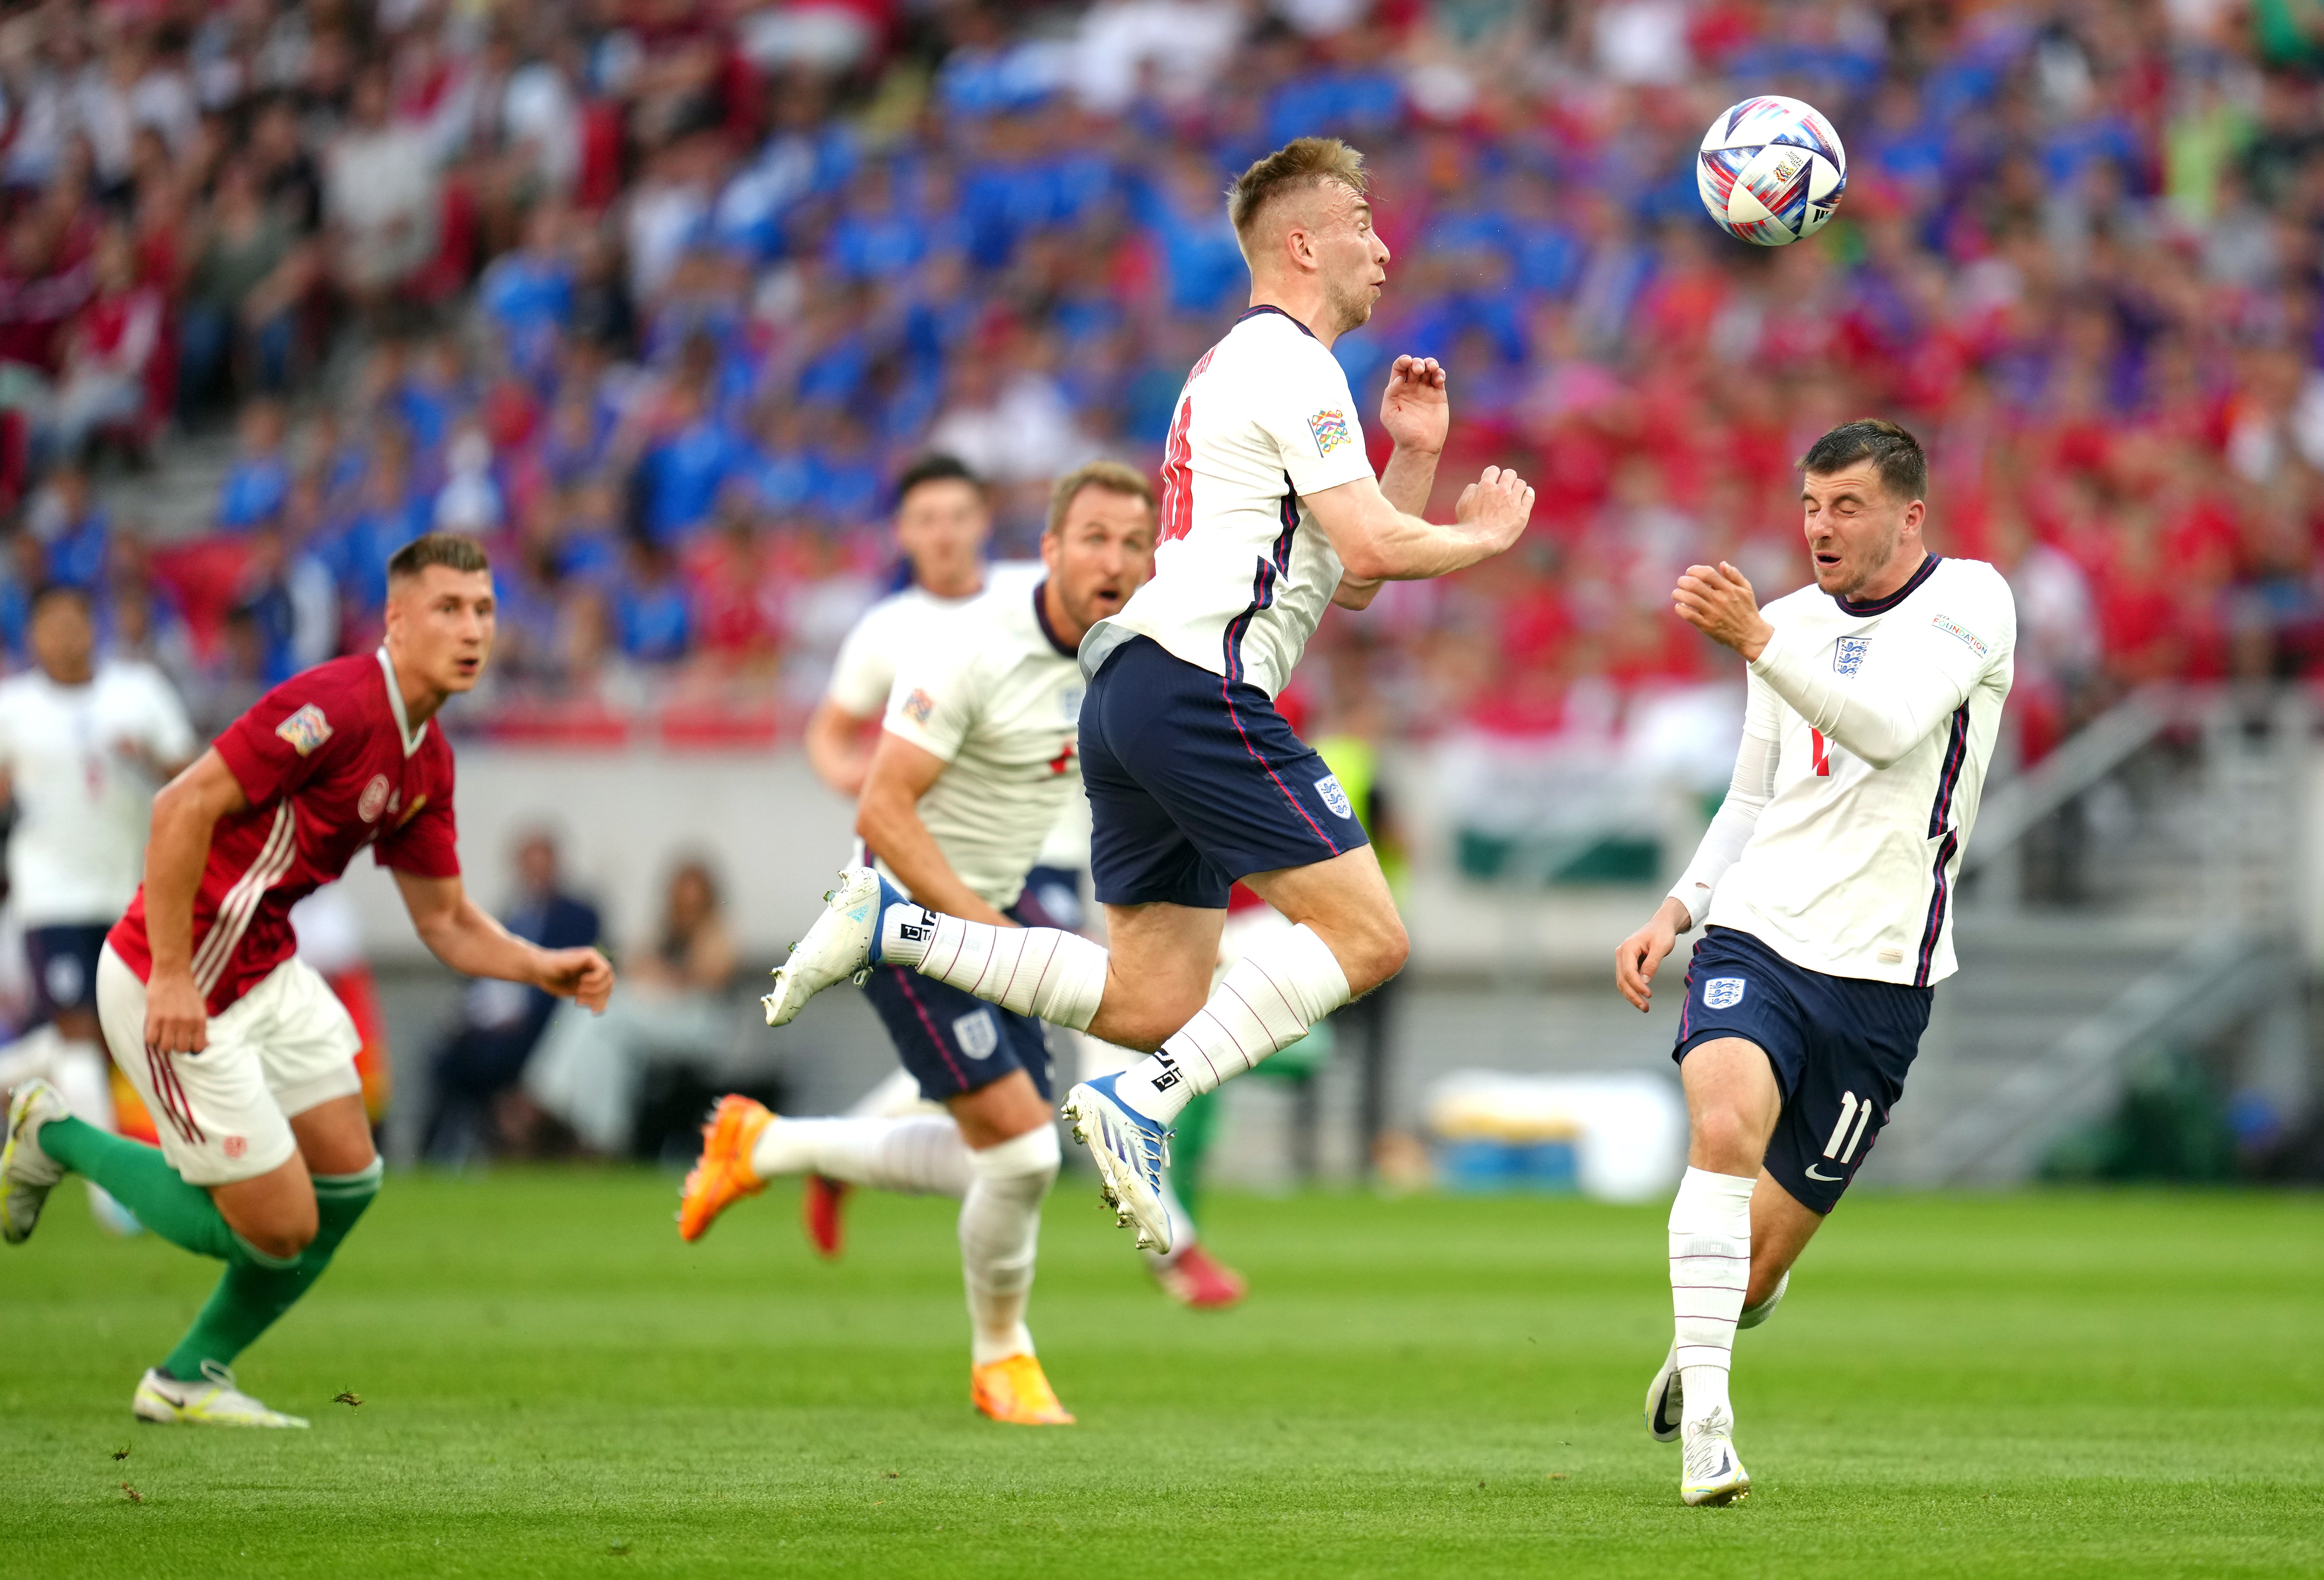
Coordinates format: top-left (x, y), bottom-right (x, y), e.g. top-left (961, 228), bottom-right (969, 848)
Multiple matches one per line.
top-left (1671, 560), bottom-right (1976, 769)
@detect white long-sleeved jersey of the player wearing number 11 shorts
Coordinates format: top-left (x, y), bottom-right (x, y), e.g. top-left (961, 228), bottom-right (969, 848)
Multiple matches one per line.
top-left (1706, 555), bottom-right (2017, 987)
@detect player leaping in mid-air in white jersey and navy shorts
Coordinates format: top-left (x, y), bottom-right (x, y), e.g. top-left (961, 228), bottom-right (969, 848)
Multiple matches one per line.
top-left (767, 137), bottom-right (1534, 1250)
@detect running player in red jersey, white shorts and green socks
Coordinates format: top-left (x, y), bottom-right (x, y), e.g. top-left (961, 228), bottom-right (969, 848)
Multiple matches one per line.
top-left (0, 532), bottom-right (614, 1427)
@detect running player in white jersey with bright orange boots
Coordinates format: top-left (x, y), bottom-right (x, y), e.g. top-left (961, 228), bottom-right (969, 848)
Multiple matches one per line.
top-left (679, 460), bottom-right (1155, 1424)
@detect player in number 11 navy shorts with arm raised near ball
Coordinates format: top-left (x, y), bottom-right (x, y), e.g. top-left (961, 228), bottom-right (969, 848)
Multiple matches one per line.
top-left (1615, 418), bottom-right (2017, 1503)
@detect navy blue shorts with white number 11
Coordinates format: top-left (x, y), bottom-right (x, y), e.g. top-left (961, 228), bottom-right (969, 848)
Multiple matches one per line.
top-left (1671, 927), bottom-right (1936, 1213)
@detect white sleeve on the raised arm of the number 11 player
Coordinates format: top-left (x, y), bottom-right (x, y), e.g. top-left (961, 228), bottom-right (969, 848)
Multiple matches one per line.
top-left (1750, 604), bottom-right (1982, 769)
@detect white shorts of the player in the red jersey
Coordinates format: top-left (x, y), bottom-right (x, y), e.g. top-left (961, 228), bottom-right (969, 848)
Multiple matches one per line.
top-left (98, 946), bottom-right (363, 1185)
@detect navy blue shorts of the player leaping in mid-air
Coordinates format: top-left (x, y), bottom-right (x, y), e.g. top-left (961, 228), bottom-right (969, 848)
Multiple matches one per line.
top-left (1081, 637), bottom-right (1371, 911)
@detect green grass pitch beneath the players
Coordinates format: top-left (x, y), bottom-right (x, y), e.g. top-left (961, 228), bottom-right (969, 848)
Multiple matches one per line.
top-left (0, 1171), bottom-right (2324, 1580)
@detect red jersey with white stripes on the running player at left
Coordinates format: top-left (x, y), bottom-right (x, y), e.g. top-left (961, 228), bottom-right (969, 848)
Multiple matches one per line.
top-left (107, 648), bottom-right (460, 1015)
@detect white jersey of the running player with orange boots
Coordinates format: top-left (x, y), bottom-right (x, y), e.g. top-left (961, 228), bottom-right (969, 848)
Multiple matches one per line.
top-left (881, 586), bottom-right (1083, 911)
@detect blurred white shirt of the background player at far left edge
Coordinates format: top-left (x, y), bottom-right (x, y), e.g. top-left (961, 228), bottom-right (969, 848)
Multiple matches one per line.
top-left (0, 662), bottom-right (200, 927)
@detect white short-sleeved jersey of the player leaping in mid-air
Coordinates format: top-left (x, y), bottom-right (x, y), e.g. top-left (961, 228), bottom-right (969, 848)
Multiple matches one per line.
top-left (1083, 307), bottom-right (1371, 697)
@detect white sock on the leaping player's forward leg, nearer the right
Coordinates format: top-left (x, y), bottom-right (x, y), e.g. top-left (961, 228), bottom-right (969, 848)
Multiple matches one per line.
top-left (1113, 922), bottom-right (1348, 1125)
